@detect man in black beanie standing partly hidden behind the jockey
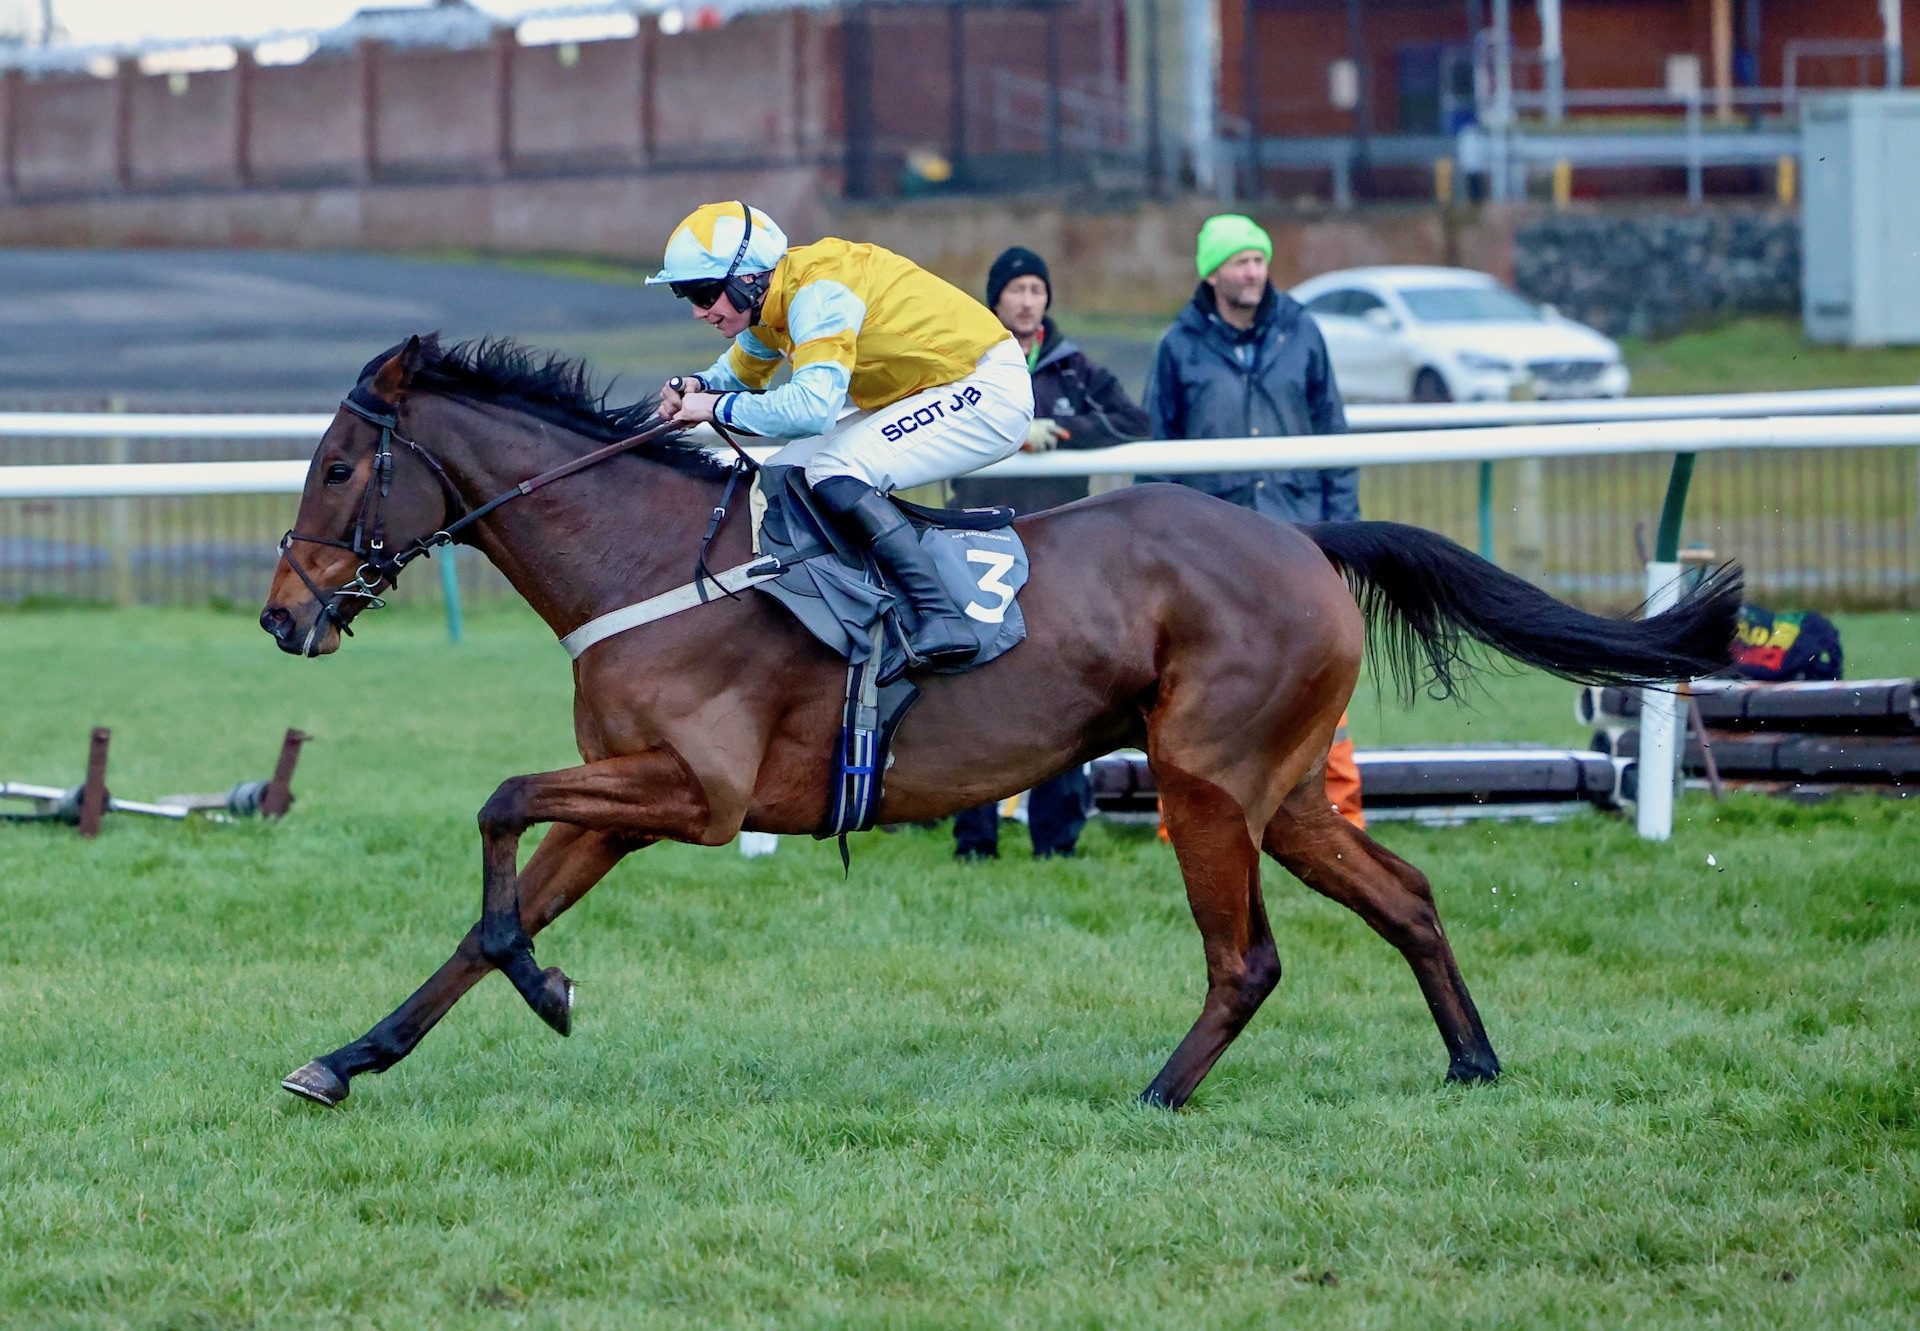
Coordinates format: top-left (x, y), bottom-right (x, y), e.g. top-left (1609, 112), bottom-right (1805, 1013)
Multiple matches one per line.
top-left (952, 246), bottom-right (1146, 859)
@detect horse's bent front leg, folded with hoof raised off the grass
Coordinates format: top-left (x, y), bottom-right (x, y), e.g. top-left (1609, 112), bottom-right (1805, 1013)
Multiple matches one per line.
top-left (478, 749), bottom-right (732, 1035)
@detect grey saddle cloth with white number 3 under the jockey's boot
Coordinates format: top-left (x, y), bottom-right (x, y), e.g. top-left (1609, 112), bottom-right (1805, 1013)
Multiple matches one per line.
top-left (756, 467), bottom-right (1027, 676)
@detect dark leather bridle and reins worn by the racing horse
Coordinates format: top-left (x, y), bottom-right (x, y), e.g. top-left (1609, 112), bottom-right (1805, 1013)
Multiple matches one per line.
top-left (280, 382), bottom-right (758, 651)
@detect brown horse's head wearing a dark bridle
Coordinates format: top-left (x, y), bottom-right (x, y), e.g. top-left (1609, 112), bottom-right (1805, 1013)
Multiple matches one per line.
top-left (259, 338), bottom-right (453, 657)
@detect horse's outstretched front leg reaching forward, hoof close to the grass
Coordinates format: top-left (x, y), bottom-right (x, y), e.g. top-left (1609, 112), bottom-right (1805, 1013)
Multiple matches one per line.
top-left (280, 824), bottom-right (645, 1104)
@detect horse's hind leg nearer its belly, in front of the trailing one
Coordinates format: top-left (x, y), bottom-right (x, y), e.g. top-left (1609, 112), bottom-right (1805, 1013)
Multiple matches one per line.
top-left (1140, 761), bottom-right (1281, 1108)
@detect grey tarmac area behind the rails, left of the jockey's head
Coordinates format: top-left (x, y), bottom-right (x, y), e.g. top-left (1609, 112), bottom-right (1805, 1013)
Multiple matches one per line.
top-left (0, 250), bottom-right (718, 411)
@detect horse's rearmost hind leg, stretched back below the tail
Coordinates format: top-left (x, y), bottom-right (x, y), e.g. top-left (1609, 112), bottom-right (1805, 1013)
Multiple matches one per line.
top-left (1261, 787), bottom-right (1500, 1081)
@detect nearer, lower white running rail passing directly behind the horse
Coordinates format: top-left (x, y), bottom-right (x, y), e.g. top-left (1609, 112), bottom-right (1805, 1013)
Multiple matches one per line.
top-left (0, 413), bottom-right (1920, 499)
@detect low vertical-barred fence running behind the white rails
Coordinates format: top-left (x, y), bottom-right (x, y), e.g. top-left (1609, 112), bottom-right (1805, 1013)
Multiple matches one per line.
top-left (11, 390), bottom-right (1920, 609)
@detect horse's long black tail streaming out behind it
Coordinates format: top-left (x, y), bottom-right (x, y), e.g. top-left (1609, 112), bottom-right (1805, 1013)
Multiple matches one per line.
top-left (1300, 522), bottom-right (1741, 701)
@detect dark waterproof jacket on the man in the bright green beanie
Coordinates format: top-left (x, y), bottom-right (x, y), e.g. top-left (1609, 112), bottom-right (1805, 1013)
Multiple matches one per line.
top-left (1140, 282), bottom-right (1359, 522)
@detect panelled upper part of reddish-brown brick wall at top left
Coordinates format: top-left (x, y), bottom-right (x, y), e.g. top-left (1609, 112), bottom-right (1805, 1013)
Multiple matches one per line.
top-left (0, 13), bottom-right (837, 207)
